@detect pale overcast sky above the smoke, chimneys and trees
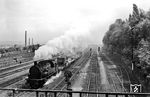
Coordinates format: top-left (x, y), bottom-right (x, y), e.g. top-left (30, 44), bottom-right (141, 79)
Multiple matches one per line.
top-left (0, 0), bottom-right (150, 43)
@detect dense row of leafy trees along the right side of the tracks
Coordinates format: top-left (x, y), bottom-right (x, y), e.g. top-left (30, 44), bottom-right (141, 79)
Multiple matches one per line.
top-left (103, 4), bottom-right (150, 66)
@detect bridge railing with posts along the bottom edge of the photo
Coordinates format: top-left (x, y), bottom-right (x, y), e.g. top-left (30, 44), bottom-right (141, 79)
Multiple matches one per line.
top-left (0, 89), bottom-right (150, 97)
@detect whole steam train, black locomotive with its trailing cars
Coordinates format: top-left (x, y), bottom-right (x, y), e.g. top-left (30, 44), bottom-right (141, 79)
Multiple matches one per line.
top-left (26, 56), bottom-right (80, 89)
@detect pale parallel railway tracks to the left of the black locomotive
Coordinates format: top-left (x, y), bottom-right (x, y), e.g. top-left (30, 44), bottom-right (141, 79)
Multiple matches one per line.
top-left (0, 61), bottom-right (33, 88)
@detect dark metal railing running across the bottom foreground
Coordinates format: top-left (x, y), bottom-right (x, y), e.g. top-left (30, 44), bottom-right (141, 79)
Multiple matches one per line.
top-left (0, 89), bottom-right (150, 97)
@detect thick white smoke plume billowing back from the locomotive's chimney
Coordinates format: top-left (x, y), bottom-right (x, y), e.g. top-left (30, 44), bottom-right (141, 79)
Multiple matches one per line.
top-left (34, 21), bottom-right (91, 60)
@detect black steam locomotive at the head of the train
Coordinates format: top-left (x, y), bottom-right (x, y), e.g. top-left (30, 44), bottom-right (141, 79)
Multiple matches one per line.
top-left (27, 60), bottom-right (58, 89)
